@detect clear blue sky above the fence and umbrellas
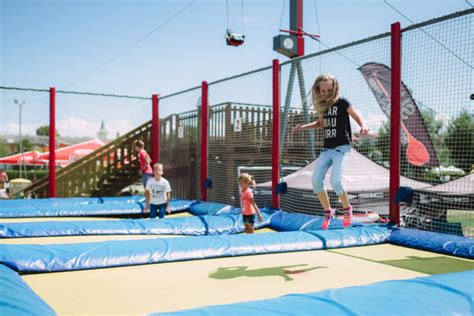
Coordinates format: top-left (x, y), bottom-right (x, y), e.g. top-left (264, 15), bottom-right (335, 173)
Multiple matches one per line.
top-left (0, 0), bottom-right (472, 137)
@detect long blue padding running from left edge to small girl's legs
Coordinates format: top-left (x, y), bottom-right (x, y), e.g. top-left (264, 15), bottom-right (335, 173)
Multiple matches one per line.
top-left (0, 212), bottom-right (273, 238)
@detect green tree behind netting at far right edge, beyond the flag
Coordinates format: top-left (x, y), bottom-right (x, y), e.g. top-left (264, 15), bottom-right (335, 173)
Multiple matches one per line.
top-left (445, 110), bottom-right (474, 173)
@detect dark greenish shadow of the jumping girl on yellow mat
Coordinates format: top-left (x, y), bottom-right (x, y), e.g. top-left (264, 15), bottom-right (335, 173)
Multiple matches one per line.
top-left (209, 264), bottom-right (327, 281)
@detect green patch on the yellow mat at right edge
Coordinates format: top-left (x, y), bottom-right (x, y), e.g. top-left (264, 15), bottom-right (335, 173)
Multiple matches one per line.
top-left (379, 256), bottom-right (474, 274)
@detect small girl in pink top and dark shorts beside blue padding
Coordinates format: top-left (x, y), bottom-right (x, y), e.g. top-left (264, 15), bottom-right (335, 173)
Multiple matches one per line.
top-left (239, 173), bottom-right (263, 234)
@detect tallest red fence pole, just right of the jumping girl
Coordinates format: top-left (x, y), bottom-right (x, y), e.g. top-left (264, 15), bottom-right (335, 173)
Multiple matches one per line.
top-left (389, 22), bottom-right (402, 225)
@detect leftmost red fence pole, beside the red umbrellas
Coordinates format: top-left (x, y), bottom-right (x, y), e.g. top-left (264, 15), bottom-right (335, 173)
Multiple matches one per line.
top-left (48, 88), bottom-right (56, 198)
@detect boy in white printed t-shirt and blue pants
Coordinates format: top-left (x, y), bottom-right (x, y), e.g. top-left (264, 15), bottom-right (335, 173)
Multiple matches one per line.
top-left (145, 163), bottom-right (171, 218)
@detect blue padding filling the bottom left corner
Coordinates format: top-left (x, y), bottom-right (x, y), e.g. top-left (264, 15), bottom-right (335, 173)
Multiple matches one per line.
top-left (0, 264), bottom-right (56, 316)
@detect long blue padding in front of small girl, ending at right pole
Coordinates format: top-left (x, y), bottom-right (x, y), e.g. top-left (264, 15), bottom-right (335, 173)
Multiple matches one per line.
top-left (0, 225), bottom-right (390, 272)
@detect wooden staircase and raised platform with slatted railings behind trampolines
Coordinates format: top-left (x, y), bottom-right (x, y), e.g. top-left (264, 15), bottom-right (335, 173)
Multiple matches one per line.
top-left (23, 103), bottom-right (318, 199)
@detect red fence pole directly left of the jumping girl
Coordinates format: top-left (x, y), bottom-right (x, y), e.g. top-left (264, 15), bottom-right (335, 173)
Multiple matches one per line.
top-left (272, 59), bottom-right (280, 208)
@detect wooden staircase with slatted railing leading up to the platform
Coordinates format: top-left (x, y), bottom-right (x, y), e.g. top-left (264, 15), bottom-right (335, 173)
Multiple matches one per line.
top-left (23, 121), bottom-right (151, 197)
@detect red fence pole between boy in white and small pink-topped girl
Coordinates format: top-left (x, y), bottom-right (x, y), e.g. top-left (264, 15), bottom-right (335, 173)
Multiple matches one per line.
top-left (201, 81), bottom-right (209, 201)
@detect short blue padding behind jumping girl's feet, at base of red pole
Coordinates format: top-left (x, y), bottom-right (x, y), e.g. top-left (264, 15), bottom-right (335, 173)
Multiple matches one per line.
top-left (270, 212), bottom-right (364, 231)
